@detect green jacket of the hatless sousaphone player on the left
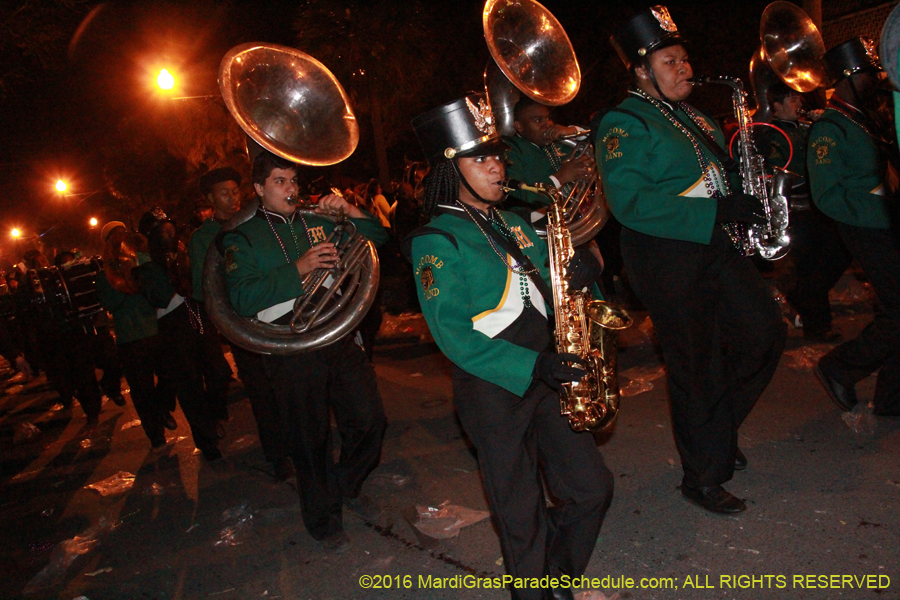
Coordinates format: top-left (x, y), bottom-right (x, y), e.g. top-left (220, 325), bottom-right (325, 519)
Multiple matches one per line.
top-left (224, 209), bottom-right (388, 323)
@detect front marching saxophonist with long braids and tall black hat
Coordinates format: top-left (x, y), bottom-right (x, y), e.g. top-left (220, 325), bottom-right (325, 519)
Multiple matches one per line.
top-left (411, 95), bottom-right (613, 599)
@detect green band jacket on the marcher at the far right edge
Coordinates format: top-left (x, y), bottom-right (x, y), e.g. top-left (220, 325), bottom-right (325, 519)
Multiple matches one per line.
top-left (807, 106), bottom-right (897, 229)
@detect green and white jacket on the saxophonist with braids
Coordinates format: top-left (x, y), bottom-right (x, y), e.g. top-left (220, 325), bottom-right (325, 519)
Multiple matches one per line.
top-left (411, 204), bottom-right (552, 396)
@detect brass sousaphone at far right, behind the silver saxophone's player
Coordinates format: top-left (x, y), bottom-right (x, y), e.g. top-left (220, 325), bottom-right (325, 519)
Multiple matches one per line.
top-left (750, 1), bottom-right (825, 123)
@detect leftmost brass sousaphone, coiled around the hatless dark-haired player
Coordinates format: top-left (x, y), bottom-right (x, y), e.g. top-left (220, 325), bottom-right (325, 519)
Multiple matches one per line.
top-left (203, 43), bottom-right (380, 355)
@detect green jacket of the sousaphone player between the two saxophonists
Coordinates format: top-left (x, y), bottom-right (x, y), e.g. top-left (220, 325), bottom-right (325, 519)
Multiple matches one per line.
top-left (503, 135), bottom-right (572, 208)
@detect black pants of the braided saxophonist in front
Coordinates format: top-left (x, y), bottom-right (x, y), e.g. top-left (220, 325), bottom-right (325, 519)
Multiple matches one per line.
top-left (453, 367), bottom-right (613, 600)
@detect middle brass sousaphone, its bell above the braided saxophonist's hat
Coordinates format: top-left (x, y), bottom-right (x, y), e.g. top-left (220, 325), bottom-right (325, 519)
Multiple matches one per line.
top-left (482, 0), bottom-right (609, 246)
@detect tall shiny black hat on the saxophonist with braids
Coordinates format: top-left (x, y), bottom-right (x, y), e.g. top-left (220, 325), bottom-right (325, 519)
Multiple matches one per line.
top-left (412, 94), bottom-right (508, 164)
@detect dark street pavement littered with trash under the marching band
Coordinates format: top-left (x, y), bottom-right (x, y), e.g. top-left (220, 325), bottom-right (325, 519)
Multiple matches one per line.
top-left (0, 281), bottom-right (900, 600)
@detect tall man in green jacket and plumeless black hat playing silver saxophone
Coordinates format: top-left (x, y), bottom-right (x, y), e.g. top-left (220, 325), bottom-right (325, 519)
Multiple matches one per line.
top-left (596, 6), bottom-right (786, 513)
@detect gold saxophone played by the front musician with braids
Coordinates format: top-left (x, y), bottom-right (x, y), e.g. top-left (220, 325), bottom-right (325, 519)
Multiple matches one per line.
top-left (504, 179), bottom-right (631, 432)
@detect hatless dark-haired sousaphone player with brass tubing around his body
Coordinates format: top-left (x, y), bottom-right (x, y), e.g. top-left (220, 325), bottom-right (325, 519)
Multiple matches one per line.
top-left (224, 151), bottom-right (388, 552)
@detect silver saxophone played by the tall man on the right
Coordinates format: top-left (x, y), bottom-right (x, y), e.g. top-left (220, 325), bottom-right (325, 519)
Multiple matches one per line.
top-left (692, 77), bottom-right (794, 260)
